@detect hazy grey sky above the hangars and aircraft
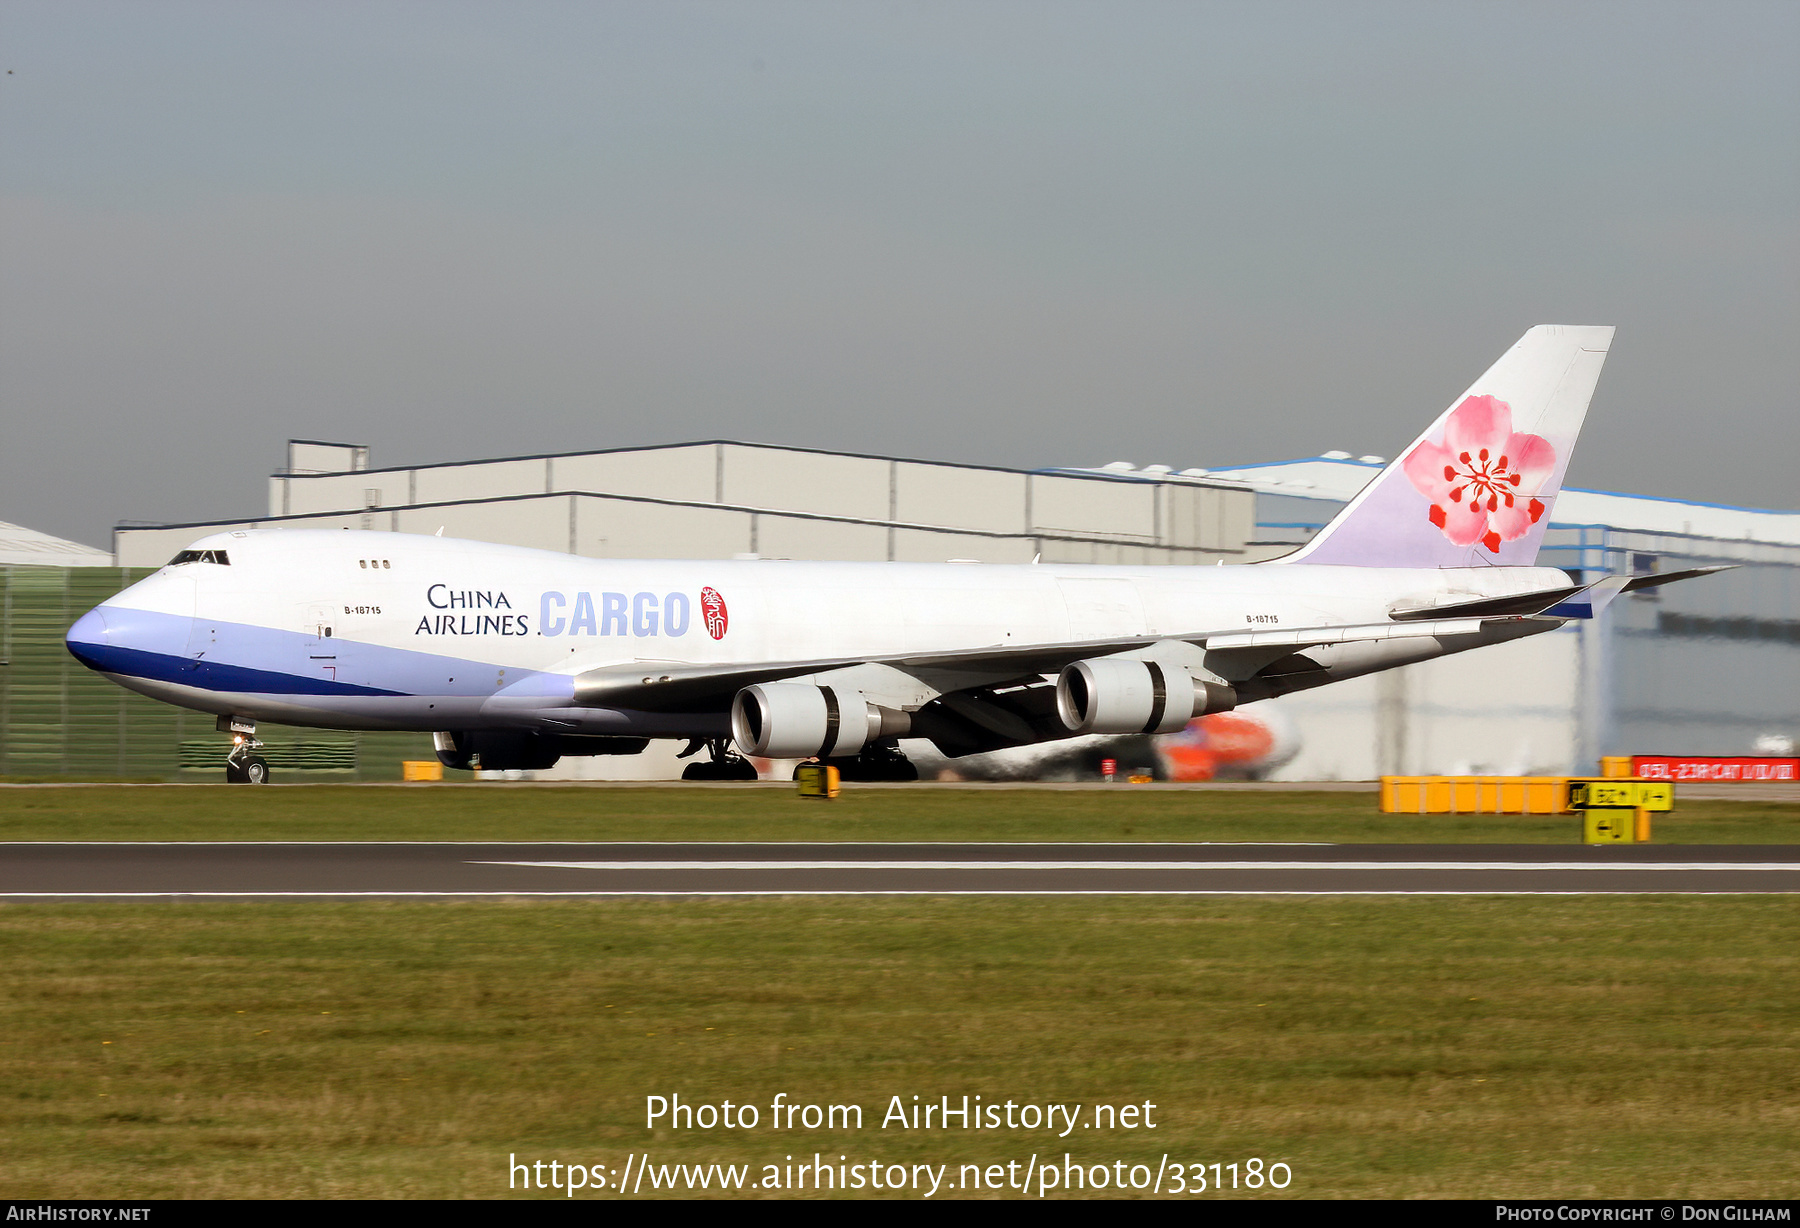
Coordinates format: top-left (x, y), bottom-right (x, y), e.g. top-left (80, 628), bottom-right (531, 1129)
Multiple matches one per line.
top-left (0, 0), bottom-right (1800, 544)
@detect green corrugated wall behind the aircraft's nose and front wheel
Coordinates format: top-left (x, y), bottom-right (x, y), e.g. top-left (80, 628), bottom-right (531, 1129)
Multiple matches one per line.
top-left (0, 567), bottom-right (432, 780)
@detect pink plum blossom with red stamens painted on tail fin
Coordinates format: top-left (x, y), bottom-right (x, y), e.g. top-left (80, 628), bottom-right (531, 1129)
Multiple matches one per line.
top-left (1404, 396), bottom-right (1557, 553)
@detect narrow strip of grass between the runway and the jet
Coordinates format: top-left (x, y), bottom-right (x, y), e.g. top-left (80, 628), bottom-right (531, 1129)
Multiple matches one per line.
top-left (0, 785), bottom-right (1800, 844)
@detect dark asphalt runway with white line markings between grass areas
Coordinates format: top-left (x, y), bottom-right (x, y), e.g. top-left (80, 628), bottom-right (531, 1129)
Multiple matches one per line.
top-left (10, 843), bottom-right (1800, 900)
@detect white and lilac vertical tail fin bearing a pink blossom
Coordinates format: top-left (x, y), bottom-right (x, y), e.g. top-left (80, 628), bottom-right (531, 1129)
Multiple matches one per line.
top-left (1280, 324), bottom-right (1613, 567)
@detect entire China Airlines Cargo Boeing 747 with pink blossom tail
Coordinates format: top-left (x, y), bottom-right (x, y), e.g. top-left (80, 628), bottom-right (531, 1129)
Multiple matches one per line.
top-left (68, 324), bottom-right (1701, 781)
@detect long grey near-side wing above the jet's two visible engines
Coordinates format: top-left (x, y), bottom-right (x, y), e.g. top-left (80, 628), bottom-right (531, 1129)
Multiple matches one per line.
top-left (574, 618), bottom-right (1521, 711)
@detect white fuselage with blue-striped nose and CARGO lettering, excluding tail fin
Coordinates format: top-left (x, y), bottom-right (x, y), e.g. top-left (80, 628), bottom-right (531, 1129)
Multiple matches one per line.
top-left (68, 531), bottom-right (1568, 736)
